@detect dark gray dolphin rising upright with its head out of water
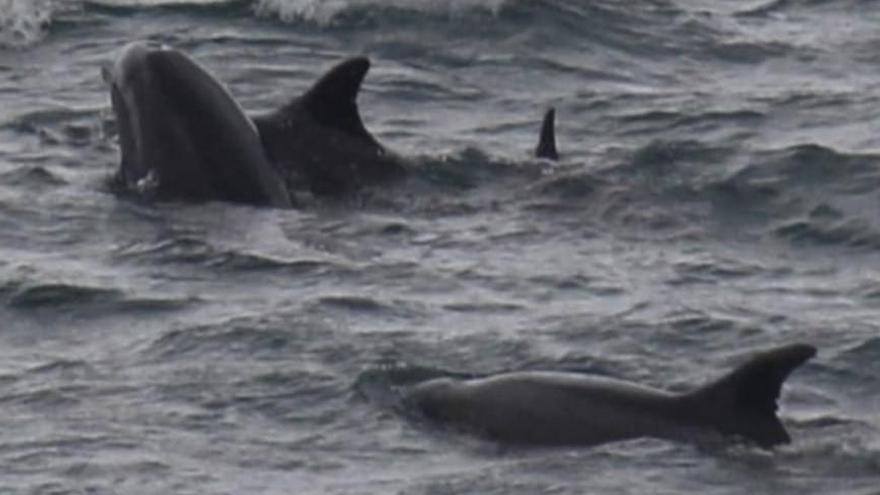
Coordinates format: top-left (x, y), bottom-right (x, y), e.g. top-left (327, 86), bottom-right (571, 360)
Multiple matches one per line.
top-left (104, 43), bottom-right (291, 207)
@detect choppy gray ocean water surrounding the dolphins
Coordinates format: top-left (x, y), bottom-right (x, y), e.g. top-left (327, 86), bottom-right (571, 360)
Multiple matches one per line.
top-left (0, 0), bottom-right (880, 495)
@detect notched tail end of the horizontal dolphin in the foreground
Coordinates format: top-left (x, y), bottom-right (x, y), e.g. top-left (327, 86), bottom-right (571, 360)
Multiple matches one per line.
top-left (688, 344), bottom-right (816, 448)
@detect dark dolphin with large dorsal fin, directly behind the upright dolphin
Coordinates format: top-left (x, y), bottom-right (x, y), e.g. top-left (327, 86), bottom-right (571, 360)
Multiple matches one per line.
top-left (253, 57), bottom-right (406, 195)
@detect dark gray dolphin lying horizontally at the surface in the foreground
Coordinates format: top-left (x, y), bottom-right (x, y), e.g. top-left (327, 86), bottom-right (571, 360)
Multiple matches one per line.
top-left (406, 344), bottom-right (816, 448)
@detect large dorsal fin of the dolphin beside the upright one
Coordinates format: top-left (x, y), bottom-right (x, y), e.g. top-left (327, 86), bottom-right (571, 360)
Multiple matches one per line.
top-left (300, 57), bottom-right (378, 144)
